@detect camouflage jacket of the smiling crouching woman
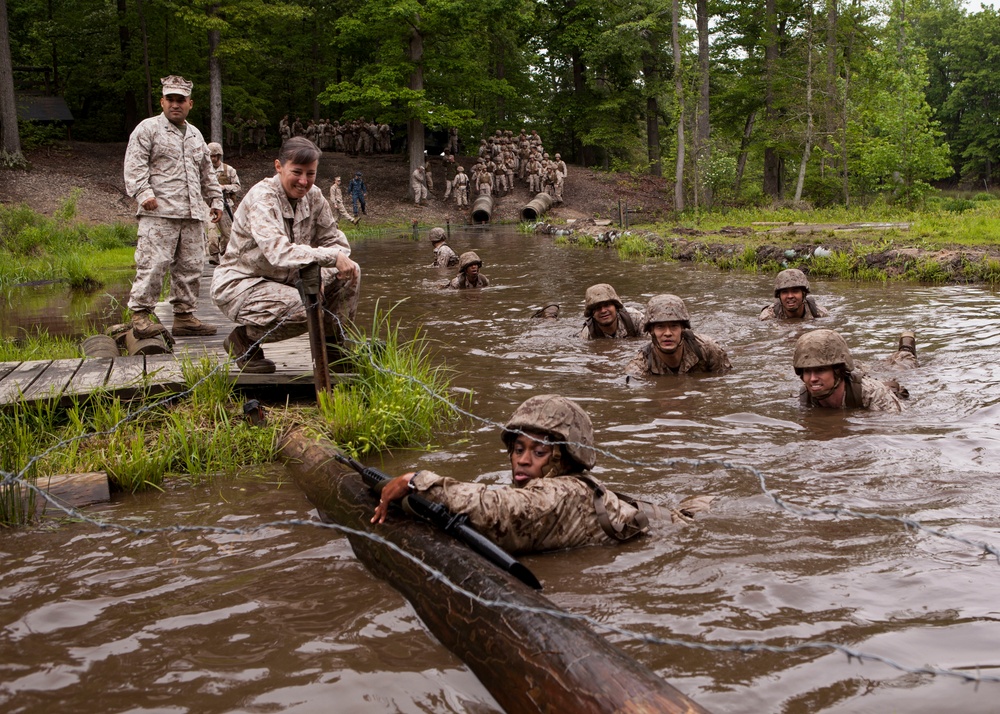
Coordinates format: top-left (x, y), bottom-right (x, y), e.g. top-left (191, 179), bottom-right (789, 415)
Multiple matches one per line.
top-left (212, 176), bottom-right (351, 318)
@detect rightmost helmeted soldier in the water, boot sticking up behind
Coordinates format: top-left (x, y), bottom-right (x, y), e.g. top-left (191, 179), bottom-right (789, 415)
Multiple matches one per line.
top-left (792, 330), bottom-right (917, 412)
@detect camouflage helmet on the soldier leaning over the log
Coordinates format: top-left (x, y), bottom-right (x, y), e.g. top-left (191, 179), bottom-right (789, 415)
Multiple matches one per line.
top-left (500, 394), bottom-right (597, 470)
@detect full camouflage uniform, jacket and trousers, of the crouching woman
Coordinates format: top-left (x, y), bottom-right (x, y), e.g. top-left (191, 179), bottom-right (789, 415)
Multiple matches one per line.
top-left (212, 176), bottom-right (361, 342)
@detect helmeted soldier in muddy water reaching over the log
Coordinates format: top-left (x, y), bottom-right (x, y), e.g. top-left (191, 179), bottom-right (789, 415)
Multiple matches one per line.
top-left (372, 394), bottom-right (711, 553)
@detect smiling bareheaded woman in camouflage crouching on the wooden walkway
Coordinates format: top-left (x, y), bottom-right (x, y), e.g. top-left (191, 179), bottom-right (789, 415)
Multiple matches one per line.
top-left (212, 137), bottom-right (361, 374)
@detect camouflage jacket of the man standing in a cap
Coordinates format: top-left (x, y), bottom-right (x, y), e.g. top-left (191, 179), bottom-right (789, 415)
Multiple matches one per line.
top-left (125, 114), bottom-right (222, 221)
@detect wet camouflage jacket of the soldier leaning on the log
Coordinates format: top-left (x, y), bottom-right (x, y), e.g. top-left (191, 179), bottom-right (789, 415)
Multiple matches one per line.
top-left (411, 471), bottom-right (638, 553)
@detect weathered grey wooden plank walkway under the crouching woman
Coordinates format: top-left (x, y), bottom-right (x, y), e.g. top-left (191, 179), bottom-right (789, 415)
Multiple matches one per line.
top-left (0, 264), bottom-right (322, 406)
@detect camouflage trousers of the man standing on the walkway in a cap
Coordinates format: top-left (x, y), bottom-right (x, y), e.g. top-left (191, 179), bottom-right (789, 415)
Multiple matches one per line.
top-left (128, 216), bottom-right (205, 314)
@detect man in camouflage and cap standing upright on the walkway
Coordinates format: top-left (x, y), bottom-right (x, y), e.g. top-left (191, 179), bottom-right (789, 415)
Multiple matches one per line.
top-left (125, 75), bottom-right (222, 339)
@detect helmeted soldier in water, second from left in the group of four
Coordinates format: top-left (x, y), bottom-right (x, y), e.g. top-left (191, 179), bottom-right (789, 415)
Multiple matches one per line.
top-left (625, 295), bottom-right (733, 377)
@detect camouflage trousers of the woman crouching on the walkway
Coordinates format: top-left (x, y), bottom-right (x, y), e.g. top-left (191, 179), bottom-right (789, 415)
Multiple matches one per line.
top-left (228, 264), bottom-right (361, 342)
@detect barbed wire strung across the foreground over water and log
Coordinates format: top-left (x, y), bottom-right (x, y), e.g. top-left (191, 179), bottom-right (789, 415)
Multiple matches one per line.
top-left (0, 304), bottom-right (1000, 686)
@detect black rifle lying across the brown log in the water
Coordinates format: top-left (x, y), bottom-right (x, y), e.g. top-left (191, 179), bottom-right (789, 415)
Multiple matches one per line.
top-left (335, 453), bottom-right (542, 590)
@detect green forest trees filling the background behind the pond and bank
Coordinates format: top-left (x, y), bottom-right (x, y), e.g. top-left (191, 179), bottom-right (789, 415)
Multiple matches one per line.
top-left (0, 0), bottom-right (1000, 210)
